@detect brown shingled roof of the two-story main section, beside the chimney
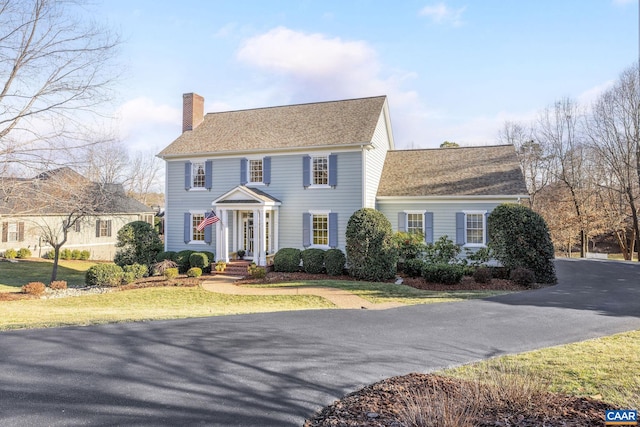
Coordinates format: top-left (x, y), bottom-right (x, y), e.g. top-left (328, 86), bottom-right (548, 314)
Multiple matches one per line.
top-left (159, 96), bottom-right (386, 157)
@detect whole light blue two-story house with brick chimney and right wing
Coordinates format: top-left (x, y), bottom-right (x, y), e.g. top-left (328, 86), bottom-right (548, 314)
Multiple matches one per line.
top-left (159, 93), bottom-right (528, 265)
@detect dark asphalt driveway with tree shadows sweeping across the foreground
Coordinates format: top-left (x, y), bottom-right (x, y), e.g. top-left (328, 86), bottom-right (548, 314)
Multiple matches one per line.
top-left (0, 260), bottom-right (640, 426)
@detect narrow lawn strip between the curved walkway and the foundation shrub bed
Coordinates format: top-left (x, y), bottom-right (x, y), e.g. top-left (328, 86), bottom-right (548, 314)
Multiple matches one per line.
top-left (244, 280), bottom-right (506, 304)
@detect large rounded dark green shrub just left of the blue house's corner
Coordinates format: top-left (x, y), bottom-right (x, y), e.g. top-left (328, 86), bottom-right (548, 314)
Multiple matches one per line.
top-left (113, 221), bottom-right (163, 267)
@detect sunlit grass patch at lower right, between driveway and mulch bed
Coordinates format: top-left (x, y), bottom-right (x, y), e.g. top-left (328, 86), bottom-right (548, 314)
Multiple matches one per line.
top-left (440, 331), bottom-right (640, 409)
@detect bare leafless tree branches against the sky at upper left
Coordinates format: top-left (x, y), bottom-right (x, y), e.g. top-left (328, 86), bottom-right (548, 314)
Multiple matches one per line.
top-left (0, 0), bottom-right (119, 173)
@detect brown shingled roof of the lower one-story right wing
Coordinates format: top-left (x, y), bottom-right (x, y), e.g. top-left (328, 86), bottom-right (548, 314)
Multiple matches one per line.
top-left (378, 145), bottom-right (528, 197)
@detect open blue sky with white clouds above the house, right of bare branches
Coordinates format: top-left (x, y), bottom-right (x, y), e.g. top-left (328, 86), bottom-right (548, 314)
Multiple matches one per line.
top-left (98, 0), bottom-right (639, 152)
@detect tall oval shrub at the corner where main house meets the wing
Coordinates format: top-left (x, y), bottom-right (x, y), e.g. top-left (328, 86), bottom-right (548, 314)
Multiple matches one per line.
top-left (346, 208), bottom-right (398, 281)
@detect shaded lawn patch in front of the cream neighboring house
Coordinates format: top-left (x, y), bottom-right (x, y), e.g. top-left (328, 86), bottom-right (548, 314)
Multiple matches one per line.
top-left (0, 259), bottom-right (95, 292)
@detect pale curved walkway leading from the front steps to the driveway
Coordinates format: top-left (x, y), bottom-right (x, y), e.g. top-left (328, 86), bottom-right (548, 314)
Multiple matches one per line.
top-left (202, 275), bottom-right (404, 310)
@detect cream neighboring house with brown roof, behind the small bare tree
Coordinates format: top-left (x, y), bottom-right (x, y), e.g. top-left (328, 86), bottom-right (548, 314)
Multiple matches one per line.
top-left (0, 168), bottom-right (154, 260)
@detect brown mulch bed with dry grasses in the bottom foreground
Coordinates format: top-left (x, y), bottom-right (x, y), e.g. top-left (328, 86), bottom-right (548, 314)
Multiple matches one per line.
top-left (304, 374), bottom-right (616, 427)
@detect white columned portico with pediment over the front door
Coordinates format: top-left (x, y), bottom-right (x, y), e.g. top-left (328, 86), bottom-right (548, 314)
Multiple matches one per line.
top-left (212, 185), bottom-right (282, 266)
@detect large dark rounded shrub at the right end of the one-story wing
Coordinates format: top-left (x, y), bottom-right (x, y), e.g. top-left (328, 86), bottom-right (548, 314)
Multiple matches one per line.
top-left (488, 204), bottom-right (557, 283)
